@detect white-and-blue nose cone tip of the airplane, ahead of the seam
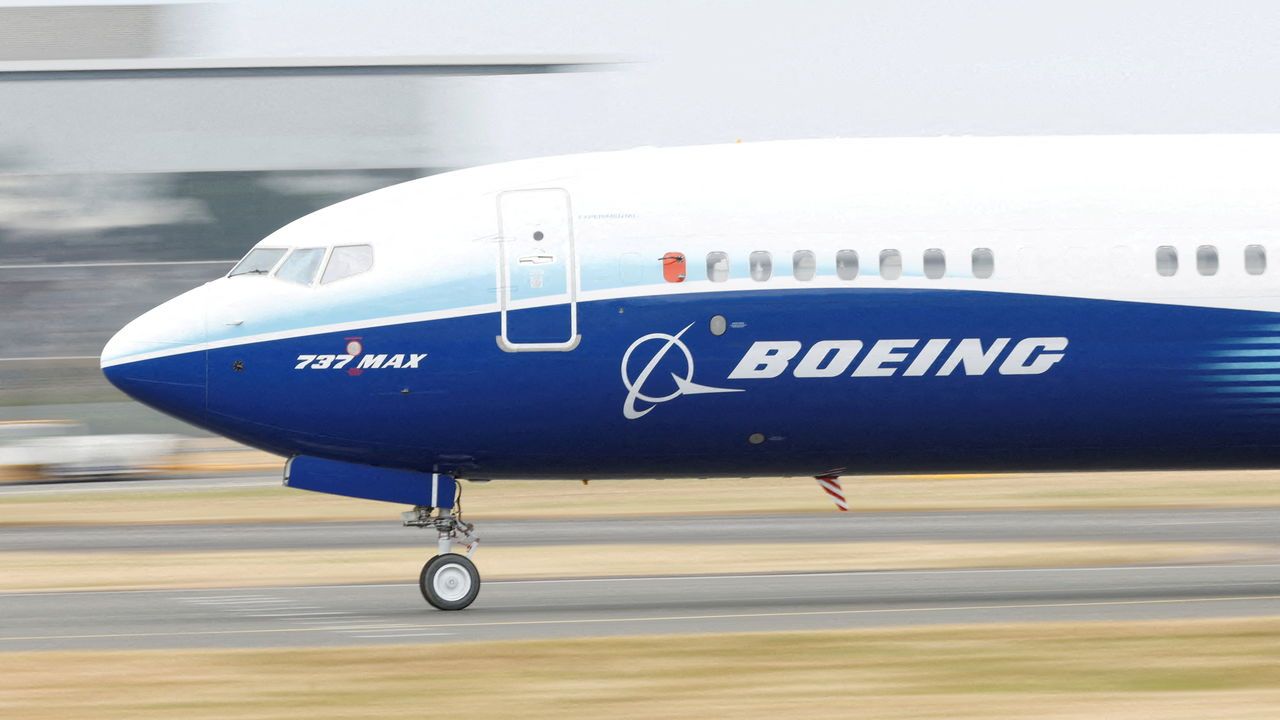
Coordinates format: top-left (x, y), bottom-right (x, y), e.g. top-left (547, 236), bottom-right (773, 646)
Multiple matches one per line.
top-left (101, 283), bottom-right (205, 423)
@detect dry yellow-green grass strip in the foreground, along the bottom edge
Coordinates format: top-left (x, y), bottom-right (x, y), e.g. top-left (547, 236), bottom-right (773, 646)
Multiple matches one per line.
top-left (0, 618), bottom-right (1280, 720)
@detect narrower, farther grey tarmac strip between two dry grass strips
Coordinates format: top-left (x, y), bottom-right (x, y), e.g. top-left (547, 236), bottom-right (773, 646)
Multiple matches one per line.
top-left (0, 507), bottom-right (1280, 552)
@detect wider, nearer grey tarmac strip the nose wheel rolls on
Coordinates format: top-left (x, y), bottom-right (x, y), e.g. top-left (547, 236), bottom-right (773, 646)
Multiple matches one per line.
top-left (0, 564), bottom-right (1280, 651)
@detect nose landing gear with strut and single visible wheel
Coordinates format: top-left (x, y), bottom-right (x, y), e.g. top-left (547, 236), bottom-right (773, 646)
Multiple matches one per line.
top-left (403, 477), bottom-right (480, 610)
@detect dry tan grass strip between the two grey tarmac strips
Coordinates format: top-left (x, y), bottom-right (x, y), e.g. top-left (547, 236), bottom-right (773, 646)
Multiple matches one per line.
top-left (0, 542), bottom-right (1276, 592)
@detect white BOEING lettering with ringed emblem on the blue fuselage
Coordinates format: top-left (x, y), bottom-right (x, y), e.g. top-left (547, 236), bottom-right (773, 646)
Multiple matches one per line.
top-left (622, 323), bottom-right (1068, 420)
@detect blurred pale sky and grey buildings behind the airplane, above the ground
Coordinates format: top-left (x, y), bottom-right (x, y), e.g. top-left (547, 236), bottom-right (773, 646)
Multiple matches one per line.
top-left (0, 0), bottom-right (1280, 469)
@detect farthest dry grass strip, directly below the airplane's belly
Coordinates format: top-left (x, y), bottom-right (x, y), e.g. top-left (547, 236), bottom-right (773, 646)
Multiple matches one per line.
top-left (0, 470), bottom-right (1280, 520)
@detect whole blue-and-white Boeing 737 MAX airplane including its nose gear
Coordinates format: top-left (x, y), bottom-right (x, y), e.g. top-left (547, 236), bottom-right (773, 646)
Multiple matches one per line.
top-left (101, 136), bottom-right (1280, 610)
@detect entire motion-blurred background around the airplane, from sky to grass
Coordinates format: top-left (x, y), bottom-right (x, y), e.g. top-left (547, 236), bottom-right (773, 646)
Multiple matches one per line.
top-left (0, 0), bottom-right (1280, 720)
